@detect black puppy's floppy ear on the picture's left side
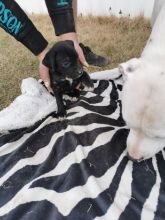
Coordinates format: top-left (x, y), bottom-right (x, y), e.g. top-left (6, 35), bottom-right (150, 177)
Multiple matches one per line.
top-left (42, 50), bottom-right (56, 71)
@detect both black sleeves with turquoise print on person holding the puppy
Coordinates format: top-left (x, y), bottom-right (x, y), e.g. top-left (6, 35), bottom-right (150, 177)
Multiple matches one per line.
top-left (0, 0), bottom-right (75, 55)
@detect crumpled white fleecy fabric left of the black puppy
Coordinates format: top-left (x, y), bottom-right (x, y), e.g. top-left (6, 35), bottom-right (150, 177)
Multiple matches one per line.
top-left (0, 78), bottom-right (57, 133)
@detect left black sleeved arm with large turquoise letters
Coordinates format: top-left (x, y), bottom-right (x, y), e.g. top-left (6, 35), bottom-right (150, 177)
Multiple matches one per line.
top-left (0, 0), bottom-right (48, 55)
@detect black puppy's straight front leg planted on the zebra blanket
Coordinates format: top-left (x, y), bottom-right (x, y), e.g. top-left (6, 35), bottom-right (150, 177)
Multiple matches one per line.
top-left (54, 90), bottom-right (66, 117)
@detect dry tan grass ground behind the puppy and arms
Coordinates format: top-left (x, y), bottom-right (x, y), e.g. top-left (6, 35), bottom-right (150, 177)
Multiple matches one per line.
top-left (0, 15), bottom-right (151, 110)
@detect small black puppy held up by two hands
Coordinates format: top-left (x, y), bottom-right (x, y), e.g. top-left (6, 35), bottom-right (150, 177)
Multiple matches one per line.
top-left (43, 40), bottom-right (93, 117)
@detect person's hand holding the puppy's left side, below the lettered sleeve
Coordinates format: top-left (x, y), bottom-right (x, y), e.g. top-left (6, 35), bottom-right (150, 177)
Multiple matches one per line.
top-left (38, 48), bottom-right (52, 92)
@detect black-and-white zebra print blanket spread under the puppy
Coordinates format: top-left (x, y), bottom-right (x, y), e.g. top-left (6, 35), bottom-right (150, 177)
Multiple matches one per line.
top-left (0, 80), bottom-right (165, 220)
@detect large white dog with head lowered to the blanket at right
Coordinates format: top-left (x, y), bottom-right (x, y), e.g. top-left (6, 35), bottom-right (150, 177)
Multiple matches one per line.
top-left (119, 0), bottom-right (165, 160)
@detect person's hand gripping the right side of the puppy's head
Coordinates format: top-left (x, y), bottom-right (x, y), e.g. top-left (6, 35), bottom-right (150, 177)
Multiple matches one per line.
top-left (60, 32), bottom-right (89, 67)
